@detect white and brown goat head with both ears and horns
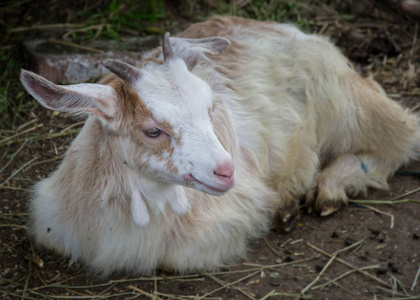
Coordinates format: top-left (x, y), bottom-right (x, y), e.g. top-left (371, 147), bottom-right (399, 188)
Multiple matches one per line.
top-left (21, 34), bottom-right (235, 195)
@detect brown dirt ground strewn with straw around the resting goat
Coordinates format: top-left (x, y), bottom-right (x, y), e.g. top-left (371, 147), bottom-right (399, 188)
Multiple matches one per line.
top-left (0, 1), bottom-right (420, 299)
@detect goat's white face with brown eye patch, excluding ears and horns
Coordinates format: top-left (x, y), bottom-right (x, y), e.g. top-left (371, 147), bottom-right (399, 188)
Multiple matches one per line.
top-left (126, 58), bottom-right (235, 194)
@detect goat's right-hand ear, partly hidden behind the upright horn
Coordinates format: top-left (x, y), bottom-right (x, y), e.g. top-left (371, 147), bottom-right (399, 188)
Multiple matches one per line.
top-left (163, 34), bottom-right (230, 70)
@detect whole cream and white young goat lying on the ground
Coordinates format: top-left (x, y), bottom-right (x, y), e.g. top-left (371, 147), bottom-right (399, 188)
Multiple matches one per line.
top-left (21, 17), bottom-right (420, 275)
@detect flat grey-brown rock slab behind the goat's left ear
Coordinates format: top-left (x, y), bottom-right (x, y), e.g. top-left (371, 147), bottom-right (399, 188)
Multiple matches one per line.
top-left (24, 36), bottom-right (159, 84)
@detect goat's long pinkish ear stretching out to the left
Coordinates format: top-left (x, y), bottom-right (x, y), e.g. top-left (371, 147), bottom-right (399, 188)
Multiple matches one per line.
top-left (20, 70), bottom-right (118, 120)
